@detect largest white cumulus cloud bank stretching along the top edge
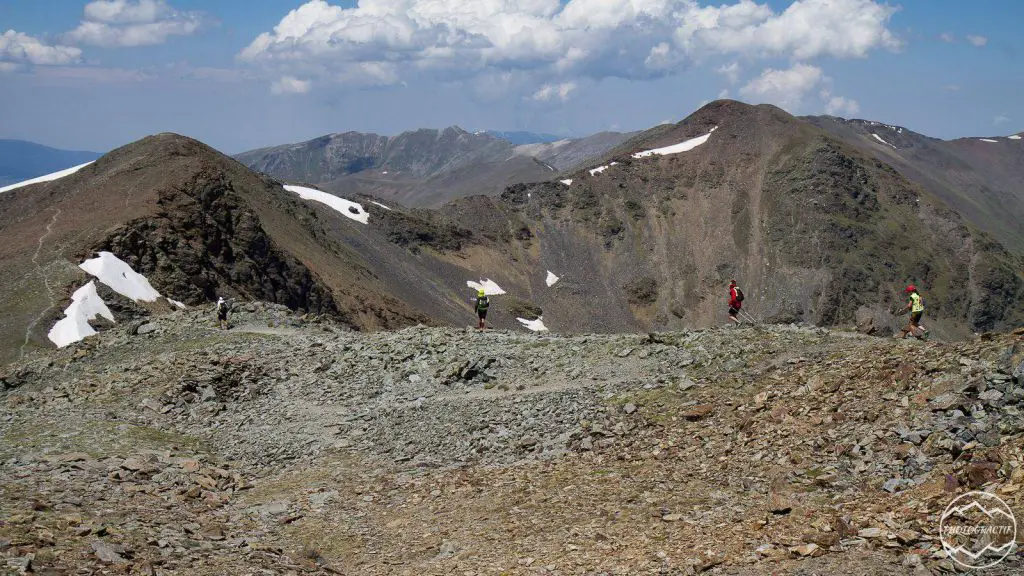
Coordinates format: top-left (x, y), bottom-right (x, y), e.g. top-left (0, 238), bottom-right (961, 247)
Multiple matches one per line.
top-left (239, 0), bottom-right (901, 89)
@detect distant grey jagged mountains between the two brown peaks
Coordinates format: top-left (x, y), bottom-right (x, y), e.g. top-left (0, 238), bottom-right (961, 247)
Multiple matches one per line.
top-left (236, 126), bottom-right (629, 207)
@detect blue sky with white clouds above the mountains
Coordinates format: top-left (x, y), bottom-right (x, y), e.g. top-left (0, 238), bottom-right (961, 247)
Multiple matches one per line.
top-left (0, 0), bottom-right (1024, 153)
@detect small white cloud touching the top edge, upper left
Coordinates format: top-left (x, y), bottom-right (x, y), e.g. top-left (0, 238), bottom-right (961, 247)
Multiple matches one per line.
top-left (62, 0), bottom-right (209, 47)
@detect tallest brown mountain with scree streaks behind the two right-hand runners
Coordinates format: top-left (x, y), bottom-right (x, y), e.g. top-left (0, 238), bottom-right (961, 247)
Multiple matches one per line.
top-left (430, 101), bottom-right (1024, 337)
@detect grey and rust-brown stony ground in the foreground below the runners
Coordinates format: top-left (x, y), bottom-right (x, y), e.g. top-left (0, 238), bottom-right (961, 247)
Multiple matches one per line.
top-left (0, 304), bottom-right (1024, 576)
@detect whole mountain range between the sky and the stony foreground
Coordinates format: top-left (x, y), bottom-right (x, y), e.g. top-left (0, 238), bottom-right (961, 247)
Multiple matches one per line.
top-left (0, 100), bottom-right (1024, 360)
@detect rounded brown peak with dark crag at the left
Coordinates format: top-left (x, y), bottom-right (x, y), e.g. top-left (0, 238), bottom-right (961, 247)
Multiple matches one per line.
top-left (0, 134), bottom-right (436, 361)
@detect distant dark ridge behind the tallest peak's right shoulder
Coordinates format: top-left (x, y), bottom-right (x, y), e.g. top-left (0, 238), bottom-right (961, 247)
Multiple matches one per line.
top-left (804, 116), bottom-right (1024, 254)
